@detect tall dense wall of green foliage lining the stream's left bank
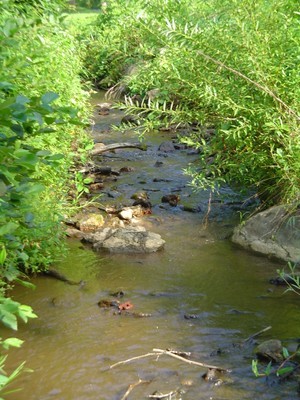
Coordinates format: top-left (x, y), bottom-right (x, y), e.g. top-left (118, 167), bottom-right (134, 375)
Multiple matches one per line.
top-left (0, 0), bottom-right (89, 276)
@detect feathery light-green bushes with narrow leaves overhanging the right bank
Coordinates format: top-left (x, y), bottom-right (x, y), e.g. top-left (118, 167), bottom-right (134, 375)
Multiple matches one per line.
top-left (82, 0), bottom-right (300, 204)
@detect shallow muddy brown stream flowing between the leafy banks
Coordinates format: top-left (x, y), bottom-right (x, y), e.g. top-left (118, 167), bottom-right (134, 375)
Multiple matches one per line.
top-left (6, 93), bottom-right (300, 400)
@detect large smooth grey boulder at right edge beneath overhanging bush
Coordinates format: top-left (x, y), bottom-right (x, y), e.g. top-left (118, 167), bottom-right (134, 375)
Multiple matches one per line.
top-left (232, 206), bottom-right (300, 262)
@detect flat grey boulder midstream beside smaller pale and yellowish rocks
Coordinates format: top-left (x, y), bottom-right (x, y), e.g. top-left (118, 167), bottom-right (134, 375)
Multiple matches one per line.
top-left (85, 226), bottom-right (165, 253)
